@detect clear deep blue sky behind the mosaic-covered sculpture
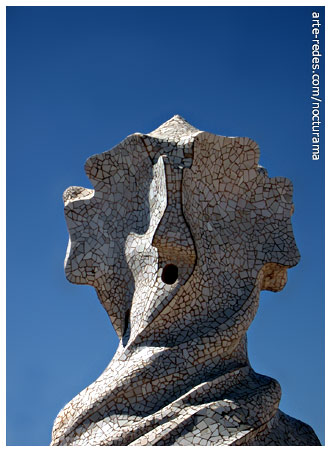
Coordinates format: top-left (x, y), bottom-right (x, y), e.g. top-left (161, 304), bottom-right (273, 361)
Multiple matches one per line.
top-left (7, 7), bottom-right (324, 445)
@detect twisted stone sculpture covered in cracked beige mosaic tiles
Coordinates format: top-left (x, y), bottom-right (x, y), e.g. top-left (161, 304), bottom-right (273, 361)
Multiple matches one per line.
top-left (52, 115), bottom-right (320, 445)
